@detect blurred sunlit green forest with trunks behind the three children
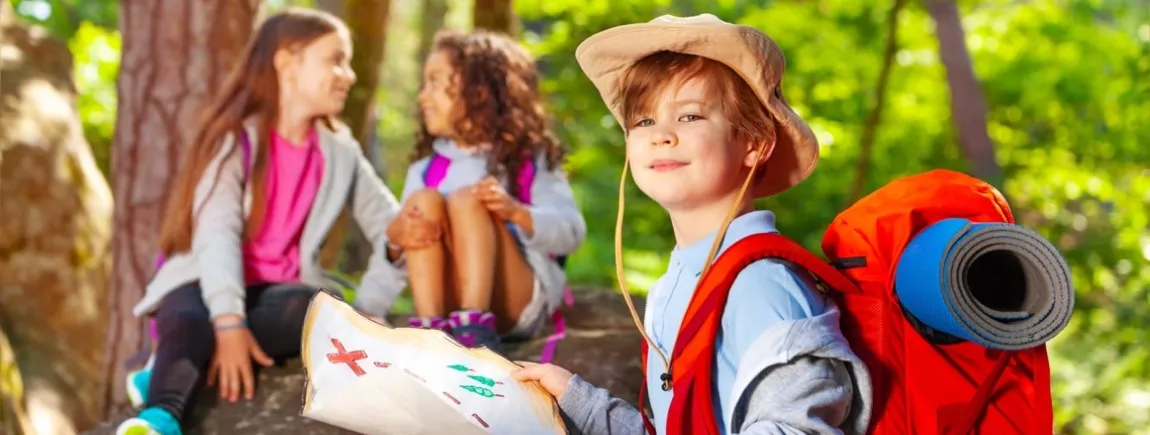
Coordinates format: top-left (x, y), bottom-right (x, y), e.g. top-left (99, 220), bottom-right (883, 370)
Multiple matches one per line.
top-left (0, 0), bottom-right (1150, 434)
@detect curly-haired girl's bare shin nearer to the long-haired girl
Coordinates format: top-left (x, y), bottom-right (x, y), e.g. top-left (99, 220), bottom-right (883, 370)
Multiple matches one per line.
top-left (404, 189), bottom-right (450, 318)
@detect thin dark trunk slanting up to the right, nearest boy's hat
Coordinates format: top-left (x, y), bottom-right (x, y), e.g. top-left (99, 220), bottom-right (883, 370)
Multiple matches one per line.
top-left (850, 0), bottom-right (906, 204)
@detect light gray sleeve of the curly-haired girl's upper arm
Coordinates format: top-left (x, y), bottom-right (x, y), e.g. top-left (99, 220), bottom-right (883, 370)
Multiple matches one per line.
top-left (523, 163), bottom-right (587, 255)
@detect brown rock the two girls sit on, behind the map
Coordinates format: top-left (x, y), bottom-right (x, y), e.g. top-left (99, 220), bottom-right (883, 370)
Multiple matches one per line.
top-left (87, 288), bottom-right (643, 435)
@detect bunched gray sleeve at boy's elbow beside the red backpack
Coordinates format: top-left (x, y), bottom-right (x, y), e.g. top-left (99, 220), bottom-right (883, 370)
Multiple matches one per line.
top-left (731, 357), bottom-right (854, 435)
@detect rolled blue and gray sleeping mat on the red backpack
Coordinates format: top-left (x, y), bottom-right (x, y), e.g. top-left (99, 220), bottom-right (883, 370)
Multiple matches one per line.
top-left (895, 219), bottom-right (1074, 350)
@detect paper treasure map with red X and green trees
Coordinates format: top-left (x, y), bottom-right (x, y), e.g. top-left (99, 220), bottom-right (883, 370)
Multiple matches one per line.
top-left (301, 291), bottom-right (567, 435)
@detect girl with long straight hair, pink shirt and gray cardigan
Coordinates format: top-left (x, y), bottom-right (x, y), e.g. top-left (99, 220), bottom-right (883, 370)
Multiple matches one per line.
top-left (117, 8), bottom-right (425, 435)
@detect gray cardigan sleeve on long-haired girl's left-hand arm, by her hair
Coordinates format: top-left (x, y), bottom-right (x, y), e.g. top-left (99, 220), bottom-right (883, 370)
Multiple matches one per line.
top-left (192, 136), bottom-right (245, 319)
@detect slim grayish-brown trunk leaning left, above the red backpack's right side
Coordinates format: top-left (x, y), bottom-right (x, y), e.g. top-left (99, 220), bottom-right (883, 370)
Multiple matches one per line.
top-left (926, 0), bottom-right (1003, 190)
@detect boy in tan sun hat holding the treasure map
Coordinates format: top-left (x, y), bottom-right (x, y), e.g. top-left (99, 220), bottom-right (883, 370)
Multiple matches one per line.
top-left (515, 14), bottom-right (871, 434)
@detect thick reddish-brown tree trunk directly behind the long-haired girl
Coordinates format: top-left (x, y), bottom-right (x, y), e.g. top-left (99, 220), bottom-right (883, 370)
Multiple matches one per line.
top-left (104, 0), bottom-right (262, 414)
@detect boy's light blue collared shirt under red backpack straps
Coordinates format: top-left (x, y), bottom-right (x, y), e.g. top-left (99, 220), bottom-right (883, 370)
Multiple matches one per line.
top-left (644, 211), bottom-right (827, 434)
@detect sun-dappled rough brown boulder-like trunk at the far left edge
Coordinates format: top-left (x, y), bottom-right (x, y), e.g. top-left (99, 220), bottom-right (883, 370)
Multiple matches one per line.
top-left (0, 1), bottom-right (113, 434)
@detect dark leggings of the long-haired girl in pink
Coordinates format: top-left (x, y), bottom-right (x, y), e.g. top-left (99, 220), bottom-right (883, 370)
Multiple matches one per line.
top-left (145, 282), bottom-right (317, 419)
